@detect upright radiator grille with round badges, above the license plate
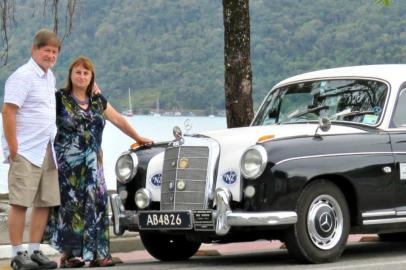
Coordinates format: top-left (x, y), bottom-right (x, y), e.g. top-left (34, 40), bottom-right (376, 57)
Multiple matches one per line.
top-left (161, 146), bottom-right (209, 210)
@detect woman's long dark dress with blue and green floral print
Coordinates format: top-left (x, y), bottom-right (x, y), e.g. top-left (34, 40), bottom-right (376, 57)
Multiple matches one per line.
top-left (47, 90), bottom-right (110, 261)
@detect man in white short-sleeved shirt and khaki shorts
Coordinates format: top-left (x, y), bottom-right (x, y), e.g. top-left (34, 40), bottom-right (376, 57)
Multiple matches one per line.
top-left (2, 29), bottom-right (61, 270)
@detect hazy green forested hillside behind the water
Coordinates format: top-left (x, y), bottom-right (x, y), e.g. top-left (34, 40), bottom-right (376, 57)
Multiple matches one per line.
top-left (0, 0), bottom-right (406, 113)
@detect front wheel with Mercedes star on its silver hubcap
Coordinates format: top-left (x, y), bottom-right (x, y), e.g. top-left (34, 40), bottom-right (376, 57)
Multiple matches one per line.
top-left (285, 180), bottom-right (350, 263)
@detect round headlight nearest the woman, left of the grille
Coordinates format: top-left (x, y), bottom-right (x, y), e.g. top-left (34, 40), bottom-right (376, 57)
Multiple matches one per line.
top-left (116, 152), bottom-right (138, 184)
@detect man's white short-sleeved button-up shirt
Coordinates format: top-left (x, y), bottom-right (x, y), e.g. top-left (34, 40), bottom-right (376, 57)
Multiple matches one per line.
top-left (2, 58), bottom-right (56, 167)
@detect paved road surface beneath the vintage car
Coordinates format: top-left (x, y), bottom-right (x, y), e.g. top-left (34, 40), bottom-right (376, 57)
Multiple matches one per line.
top-left (109, 242), bottom-right (406, 270)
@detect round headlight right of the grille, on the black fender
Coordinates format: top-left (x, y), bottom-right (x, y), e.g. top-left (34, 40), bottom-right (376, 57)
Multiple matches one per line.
top-left (241, 145), bottom-right (268, 180)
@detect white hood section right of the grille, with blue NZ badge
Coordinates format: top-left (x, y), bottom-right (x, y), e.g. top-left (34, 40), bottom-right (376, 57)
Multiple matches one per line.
top-left (199, 124), bottom-right (366, 201)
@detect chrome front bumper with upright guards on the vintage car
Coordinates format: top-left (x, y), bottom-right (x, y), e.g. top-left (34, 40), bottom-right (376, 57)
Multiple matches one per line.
top-left (110, 188), bottom-right (297, 235)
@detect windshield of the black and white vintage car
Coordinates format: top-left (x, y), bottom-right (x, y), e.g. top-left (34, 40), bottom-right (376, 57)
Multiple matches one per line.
top-left (252, 80), bottom-right (388, 126)
